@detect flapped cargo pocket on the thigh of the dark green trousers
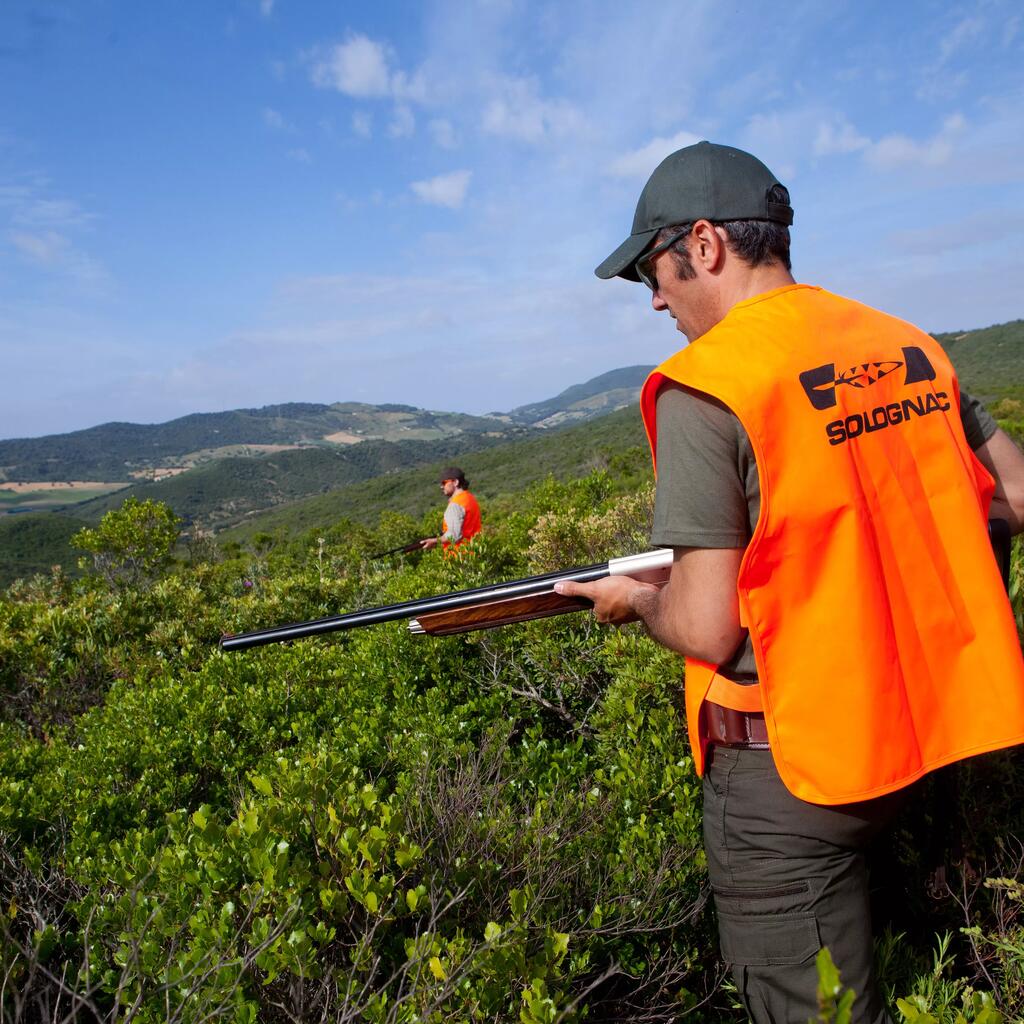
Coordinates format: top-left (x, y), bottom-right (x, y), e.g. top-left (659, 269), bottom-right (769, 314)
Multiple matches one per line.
top-left (715, 882), bottom-right (821, 967)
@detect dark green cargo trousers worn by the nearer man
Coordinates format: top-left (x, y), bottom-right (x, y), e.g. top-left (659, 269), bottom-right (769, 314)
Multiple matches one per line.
top-left (703, 746), bottom-right (904, 1024)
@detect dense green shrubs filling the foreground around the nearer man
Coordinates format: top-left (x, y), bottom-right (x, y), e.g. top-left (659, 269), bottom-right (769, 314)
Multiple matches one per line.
top-left (0, 470), bottom-right (1024, 1024)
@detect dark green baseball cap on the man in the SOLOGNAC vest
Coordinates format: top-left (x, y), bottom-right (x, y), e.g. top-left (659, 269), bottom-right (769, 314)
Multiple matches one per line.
top-left (594, 142), bottom-right (793, 281)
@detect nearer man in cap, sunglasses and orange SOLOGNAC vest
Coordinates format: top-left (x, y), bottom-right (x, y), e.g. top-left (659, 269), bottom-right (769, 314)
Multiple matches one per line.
top-left (556, 142), bottom-right (1024, 1024)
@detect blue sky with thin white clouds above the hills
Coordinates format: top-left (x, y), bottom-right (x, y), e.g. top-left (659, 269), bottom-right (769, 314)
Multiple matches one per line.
top-left (0, 0), bottom-right (1024, 437)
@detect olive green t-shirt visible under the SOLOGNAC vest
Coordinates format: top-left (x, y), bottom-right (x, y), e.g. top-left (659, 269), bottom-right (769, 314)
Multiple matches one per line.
top-left (651, 383), bottom-right (996, 682)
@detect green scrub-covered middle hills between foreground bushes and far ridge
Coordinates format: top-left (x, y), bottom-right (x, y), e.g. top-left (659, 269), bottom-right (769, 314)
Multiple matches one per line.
top-left (0, 408), bottom-right (650, 586)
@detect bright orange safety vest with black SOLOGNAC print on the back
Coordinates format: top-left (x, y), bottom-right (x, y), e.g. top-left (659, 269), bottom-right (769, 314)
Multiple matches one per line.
top-left (641, 285), bottom-right (1024, 804)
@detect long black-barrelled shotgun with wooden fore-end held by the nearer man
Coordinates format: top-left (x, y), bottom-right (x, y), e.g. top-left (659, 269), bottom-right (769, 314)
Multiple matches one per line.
top-left (220, 548), bottom-right (673, 650)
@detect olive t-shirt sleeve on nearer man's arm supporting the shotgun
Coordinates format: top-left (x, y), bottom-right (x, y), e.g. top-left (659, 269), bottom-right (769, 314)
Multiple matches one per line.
top-left (651, 384), bottom-right (750, 548)
